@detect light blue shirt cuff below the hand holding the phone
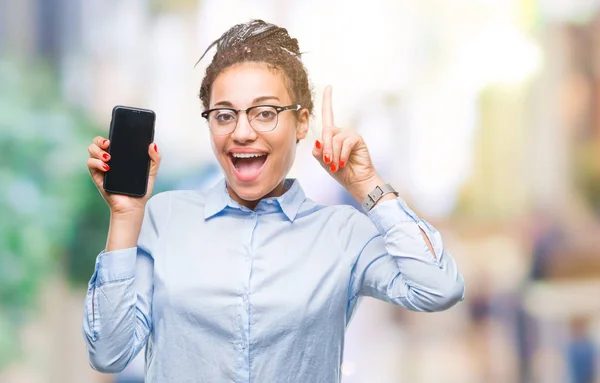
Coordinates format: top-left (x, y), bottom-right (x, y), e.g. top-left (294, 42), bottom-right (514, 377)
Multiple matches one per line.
top-left (97, 247), bottom-right (137, 285)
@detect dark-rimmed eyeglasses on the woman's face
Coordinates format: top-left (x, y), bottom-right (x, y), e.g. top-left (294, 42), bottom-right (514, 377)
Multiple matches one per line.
top-left (202, 104), bottom-right (302, 136)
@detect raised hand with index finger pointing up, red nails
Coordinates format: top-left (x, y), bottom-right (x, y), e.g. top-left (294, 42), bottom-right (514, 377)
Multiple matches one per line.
top-left (312, 86), bottom-right (381, 200)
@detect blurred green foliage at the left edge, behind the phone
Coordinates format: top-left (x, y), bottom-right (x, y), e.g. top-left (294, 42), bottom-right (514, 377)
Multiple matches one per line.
top-left (0, 59), bottom-right (108, 369)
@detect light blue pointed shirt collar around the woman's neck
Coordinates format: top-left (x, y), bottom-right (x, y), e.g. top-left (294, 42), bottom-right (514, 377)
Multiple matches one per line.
top-left (204, 178), bottom-right (306, 222)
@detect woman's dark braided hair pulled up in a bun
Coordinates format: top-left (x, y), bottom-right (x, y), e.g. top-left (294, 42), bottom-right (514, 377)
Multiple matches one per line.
top-left (198, 20), bottom-right (313, 114)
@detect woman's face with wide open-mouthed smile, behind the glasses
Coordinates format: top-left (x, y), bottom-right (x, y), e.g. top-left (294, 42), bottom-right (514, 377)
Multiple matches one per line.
top-left (209, 63), bottom-right (309, 208)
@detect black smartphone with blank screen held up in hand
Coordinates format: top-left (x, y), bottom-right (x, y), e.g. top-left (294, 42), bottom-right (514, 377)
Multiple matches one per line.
top-left (104, 105), bottom-right (156, 197)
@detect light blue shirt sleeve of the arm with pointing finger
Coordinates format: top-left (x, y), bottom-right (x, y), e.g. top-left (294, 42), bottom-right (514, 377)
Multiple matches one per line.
top-left (346, 198), bottom-right (465, 312)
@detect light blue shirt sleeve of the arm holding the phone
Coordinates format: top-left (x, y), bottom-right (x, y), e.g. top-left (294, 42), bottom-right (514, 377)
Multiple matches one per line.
top-left (83, 193), bottom-right (168, 373)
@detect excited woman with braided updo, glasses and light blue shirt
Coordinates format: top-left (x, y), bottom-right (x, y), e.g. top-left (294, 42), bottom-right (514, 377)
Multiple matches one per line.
top-left (83, 20), bottom-right (464, 382)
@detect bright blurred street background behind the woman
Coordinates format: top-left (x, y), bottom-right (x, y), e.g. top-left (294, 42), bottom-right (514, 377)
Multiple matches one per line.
top-left (0, 0), bottom-right (600, 383)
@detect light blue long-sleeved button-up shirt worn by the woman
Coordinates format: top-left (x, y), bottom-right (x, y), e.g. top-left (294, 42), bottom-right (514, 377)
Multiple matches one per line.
top-left (83, 179), bottom-right (464, 383)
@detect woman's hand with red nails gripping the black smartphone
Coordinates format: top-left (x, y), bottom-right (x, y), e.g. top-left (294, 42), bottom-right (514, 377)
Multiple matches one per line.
top-left (87, 136), bottom-right (161, 215)
